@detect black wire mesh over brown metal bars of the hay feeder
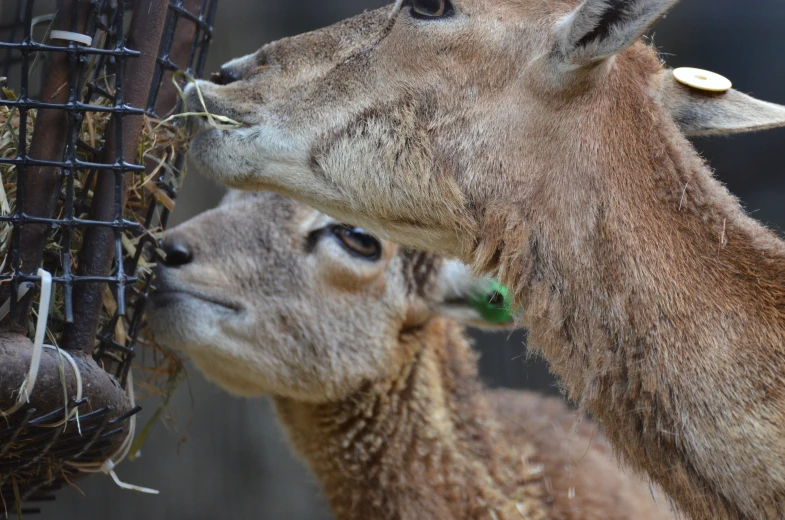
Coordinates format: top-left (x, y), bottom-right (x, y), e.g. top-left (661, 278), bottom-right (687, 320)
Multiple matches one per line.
top-left (0, 0), bottom-right (217, 382)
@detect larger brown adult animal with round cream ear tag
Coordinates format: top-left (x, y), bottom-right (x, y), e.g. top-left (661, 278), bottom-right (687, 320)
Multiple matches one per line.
top-left (188, 0), bottom-right (785, 519)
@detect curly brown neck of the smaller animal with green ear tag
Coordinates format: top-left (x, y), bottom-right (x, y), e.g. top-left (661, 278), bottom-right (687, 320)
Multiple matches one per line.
top-left (275, 320), bottom-right (540, 520)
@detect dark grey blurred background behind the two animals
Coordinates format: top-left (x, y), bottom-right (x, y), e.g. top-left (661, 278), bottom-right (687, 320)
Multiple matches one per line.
top-left (6, 0), bottom-right (785, 520)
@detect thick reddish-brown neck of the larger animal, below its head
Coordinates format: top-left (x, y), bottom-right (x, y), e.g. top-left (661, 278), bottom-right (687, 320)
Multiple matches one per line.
top-left (473, 70), bottom-right (785, 518)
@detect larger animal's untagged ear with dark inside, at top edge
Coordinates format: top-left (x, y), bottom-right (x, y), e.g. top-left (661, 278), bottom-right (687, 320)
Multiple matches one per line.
top-left (556, 0), bottom-right (678, 66)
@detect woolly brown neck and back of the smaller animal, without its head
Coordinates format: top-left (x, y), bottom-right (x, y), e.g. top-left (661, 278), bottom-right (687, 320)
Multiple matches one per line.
top-left (275, 320), bottom-right (670, 520)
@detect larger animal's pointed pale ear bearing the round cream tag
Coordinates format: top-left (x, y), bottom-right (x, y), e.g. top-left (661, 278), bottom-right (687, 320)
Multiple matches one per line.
top-left (660, 69), bottom-right (785, 137)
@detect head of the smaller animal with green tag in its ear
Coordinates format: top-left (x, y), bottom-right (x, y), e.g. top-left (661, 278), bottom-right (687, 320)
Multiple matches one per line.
top-left (148, 193), bottom-right (512, 402)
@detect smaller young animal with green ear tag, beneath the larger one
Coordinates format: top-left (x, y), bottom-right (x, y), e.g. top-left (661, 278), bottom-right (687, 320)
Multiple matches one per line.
top-left (148, 194), bottom-right (671, 520)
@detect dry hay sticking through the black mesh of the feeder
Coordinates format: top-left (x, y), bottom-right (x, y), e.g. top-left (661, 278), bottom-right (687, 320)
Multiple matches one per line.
top-left (0, 82), bottom-right (188, 430)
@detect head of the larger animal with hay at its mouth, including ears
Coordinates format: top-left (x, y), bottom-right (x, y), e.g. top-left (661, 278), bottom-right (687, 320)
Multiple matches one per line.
top-left (182, 0), bottom-right (785, 260)
